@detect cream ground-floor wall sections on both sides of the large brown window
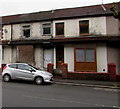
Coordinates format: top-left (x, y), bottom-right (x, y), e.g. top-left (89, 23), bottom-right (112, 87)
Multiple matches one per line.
top-left (64, 43), bottom-right (108, 73)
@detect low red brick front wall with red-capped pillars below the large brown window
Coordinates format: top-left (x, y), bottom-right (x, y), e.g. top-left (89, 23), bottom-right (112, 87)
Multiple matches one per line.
top-left (49, 63), bottom-right (120, 81)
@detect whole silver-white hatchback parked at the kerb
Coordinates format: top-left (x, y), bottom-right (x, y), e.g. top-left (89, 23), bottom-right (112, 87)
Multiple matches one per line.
top-left (2, 63), bottom-right (53, 84)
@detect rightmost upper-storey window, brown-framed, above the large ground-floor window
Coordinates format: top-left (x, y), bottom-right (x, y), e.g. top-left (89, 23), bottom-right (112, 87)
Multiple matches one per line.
top-left (79, 20), bottom-right (89, 35)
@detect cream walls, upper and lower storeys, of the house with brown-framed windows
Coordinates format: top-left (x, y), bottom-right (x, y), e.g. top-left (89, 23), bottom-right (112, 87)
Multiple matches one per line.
top-left (53, 17), bottom-right (107, 72)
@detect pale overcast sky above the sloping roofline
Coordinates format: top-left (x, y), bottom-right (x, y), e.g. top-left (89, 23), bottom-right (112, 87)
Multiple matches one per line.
top-left (0, 0), bottom-right (120, 16)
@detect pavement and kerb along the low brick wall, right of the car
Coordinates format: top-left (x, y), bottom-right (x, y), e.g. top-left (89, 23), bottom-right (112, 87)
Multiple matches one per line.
top-left (0, 75), bottom-right (120, 89)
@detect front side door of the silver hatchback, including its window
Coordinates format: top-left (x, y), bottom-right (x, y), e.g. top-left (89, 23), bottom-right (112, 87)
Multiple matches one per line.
top-left (18, 64), bottom-right (33, 80)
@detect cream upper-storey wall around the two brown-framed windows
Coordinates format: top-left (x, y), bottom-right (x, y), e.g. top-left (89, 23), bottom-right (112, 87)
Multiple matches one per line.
top-left (53, 17), bottom-right (106, 37)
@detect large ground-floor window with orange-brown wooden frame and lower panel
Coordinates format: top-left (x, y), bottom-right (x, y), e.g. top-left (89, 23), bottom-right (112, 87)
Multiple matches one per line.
top-left (74, 44), bottom-right (96, 71)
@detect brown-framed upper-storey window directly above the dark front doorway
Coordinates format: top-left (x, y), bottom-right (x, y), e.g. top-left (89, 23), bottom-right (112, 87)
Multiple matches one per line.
top-left (55, 22), bottom-right (64, 36)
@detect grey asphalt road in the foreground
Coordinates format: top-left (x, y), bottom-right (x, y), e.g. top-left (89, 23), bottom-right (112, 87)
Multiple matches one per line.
top-left (2, 81), bottom-right (119, 108)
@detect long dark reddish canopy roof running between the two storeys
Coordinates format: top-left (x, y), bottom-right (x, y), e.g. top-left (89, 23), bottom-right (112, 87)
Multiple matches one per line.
top-left (8, 36), bottom-right (120, 45)
